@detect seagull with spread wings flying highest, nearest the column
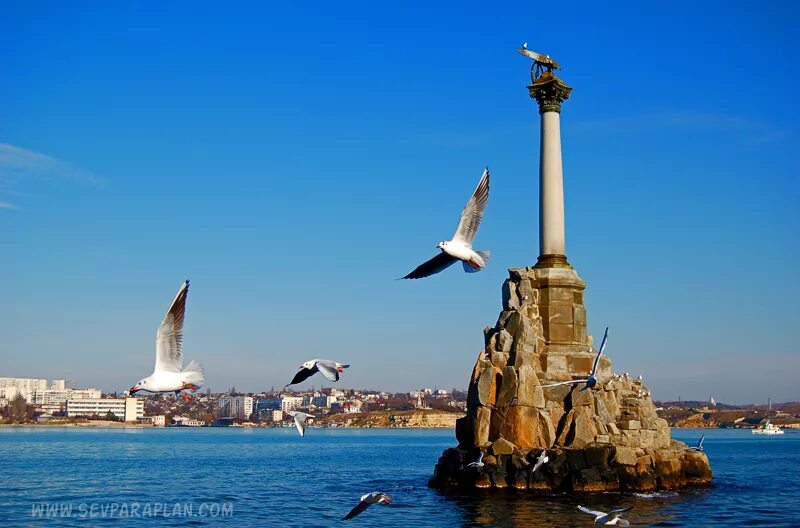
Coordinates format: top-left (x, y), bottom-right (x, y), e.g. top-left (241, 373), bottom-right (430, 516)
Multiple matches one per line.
top-left (403, 168), bottom-right (490, 279)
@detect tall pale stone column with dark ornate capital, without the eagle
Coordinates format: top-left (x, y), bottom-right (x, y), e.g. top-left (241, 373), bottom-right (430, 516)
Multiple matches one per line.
top-left (528, 71), bottom-right (572, 268)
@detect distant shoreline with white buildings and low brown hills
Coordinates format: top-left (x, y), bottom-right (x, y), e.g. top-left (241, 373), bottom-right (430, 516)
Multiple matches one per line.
top-left (0, 377), bottom-right (800, 429)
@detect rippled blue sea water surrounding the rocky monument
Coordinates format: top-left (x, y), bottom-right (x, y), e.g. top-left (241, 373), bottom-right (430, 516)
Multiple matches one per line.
top-left (0, 427), bottom-right (800, 527)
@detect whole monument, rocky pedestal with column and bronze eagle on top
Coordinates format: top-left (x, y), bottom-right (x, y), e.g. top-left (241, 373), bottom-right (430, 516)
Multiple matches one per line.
top-left (429, 46), bottom-right (712, 493)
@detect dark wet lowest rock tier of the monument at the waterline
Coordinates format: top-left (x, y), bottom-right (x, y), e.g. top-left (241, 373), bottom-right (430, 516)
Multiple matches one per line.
top-left (428, 440), bottom-right (711, 494)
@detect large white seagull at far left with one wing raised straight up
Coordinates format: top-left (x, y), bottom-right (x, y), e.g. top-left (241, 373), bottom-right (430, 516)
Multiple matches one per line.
top-left (128, 280), bottom-right (205, 402)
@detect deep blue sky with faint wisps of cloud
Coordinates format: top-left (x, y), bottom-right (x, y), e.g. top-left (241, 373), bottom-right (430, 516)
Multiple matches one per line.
top-left (0, 2), bottom-right (800, 403)
